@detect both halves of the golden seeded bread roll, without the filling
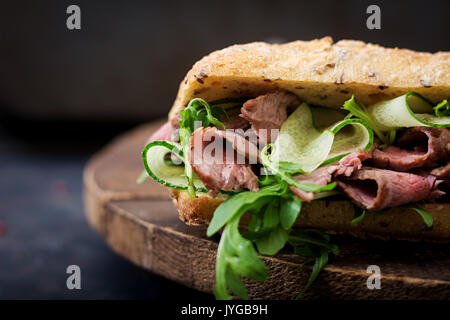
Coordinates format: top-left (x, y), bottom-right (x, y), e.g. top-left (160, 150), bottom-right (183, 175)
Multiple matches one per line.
top-left (169, 37), bottom-right (450, 242)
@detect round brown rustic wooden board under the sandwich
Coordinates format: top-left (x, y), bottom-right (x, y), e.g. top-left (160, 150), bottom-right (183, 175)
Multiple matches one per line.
top-left (84, 121), bottom-right (450, 299)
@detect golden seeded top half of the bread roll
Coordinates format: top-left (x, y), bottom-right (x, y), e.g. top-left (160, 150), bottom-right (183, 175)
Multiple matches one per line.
top-left (169, 37), bottom-right (450, 120)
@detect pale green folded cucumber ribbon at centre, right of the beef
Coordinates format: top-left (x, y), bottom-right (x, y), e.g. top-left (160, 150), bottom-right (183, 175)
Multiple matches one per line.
top-left (271, 103), bottom-right (373, 172)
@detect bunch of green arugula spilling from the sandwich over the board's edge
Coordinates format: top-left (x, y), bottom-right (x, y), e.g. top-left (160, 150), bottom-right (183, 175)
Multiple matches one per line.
top-left (207, 170), bottom-right (339, 299)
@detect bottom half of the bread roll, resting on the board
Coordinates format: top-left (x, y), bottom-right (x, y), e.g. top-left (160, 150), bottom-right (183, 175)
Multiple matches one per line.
top-left (171, 189), bottom-right (450, 242)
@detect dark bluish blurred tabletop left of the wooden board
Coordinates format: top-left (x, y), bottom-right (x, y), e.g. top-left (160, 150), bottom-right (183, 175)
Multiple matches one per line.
top-left (0, 120), bottom-right (213, 300)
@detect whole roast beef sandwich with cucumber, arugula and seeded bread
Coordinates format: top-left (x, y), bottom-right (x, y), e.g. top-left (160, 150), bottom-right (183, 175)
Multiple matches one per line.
top-left (142, 37), bottom-right (450, 299)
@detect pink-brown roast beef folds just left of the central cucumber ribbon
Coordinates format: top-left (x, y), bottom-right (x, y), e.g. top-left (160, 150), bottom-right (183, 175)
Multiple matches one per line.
top-left (185, 91), bottom-right (299, 194)
